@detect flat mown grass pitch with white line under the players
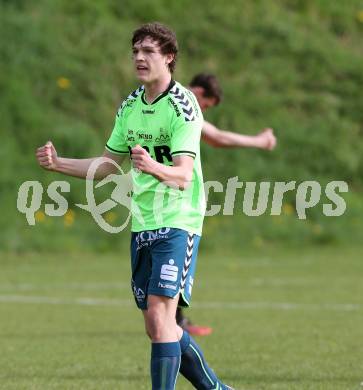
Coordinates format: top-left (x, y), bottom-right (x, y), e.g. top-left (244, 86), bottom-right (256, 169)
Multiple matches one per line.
top-left (0, 247), bottom-right (363, 390)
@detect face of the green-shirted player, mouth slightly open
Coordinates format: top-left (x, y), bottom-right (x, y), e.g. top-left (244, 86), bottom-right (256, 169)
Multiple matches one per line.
top-left (132, 37), bottom-right (173, 84)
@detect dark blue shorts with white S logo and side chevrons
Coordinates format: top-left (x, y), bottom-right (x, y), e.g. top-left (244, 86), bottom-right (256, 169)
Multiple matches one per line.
top-left (131, 228), bottom-right (200, 310)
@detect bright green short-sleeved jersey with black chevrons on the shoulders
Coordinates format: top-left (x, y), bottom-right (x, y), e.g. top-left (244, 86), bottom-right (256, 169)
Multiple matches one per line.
top-left (106, 80), bottom-right (205, 235)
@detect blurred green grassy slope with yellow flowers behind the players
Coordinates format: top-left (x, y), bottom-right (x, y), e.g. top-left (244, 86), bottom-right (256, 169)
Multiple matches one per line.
top-left (0, 0), bottom-right (363, 251)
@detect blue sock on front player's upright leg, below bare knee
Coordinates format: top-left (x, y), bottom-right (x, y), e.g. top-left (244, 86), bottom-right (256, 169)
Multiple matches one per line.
top-left (150, 341), bottom-right (180, 390)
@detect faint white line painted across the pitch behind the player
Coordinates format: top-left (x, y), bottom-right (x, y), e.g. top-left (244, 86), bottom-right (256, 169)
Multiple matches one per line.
top-left (0, 295), bottom-right (363, 312)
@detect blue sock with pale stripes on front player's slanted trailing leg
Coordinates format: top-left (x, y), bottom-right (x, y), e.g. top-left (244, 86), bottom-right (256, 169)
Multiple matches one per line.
top-left (179, 330), bottom-right (227, 390)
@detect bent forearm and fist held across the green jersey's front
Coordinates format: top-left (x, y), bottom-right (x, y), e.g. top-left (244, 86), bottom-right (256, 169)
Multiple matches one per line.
top-left (131, 145), bottom-right (194, 190)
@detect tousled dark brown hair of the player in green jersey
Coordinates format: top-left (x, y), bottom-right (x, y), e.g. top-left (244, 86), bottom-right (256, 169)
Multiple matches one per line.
top-left (132, 22), bottom-right (178, 73)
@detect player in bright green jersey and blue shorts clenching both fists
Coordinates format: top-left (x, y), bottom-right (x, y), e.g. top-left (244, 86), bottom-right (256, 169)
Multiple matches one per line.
top-left (36, 23), bottom-right (230, 390)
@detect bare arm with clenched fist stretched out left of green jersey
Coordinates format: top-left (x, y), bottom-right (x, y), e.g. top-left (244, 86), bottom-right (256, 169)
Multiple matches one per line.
top-left (36, 141), bottom-right (124, 180)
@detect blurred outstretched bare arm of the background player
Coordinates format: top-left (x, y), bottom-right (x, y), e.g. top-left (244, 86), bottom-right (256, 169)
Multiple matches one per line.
top-left (202, 121), bottom-right (276, 150)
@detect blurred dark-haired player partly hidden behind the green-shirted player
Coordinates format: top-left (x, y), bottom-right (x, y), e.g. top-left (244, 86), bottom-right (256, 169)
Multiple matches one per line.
top-left (176, 73), bottom-right (276, 336)
